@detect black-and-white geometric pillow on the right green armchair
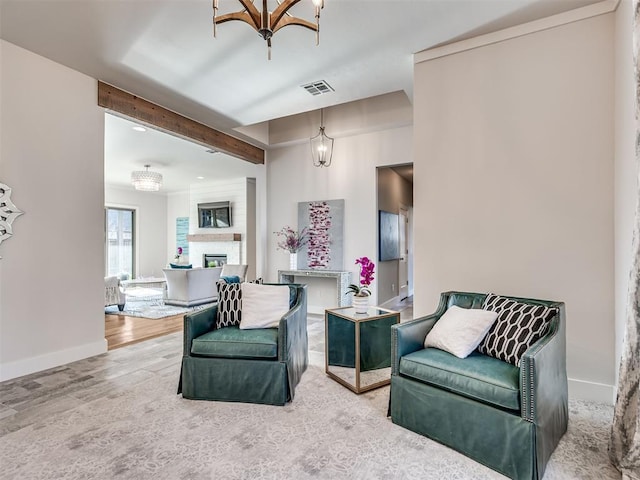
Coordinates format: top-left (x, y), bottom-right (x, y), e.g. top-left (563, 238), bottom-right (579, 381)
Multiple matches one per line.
top-left (478, 293), bottom-right (557, 366)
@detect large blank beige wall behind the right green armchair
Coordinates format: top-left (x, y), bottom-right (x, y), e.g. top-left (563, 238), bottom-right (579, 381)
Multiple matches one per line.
top-left (414, 14), bottom-right (614, 401)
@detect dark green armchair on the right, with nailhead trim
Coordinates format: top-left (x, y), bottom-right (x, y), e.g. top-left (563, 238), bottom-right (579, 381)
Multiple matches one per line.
top-left (389, 292), bottom-right (568, 480)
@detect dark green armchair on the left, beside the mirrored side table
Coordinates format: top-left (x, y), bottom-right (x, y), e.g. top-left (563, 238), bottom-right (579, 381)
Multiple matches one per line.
top-left (178, 284), bottom-right (309, 405)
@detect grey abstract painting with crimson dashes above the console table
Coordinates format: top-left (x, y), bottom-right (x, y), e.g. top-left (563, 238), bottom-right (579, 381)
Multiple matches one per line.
top-left (298, 200), bottom-right (344, 270)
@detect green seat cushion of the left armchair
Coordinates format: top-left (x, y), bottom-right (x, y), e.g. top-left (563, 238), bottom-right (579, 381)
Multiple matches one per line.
top-left (191, 325), bottom-right (278, 359)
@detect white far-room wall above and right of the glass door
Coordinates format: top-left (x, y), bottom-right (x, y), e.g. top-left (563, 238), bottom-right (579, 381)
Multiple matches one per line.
top-left (104, 186), bottom-right (168, 278)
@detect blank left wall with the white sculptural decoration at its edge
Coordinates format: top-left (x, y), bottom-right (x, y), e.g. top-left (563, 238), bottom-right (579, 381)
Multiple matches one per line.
top-left (0, 40), bottom-right (107, 380)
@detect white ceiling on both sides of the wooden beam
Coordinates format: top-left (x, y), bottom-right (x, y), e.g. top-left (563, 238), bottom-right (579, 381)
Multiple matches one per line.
top-left (0, 0), bottom-right (598, 188)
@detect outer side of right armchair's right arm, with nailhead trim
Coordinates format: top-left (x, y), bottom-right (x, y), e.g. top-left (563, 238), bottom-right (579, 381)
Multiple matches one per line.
top-left (520, 303), bottom-right (568, 424)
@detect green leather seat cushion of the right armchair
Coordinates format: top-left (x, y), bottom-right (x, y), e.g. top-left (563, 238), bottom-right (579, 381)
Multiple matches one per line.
top-left (399, 348), bottom-right (520, 411)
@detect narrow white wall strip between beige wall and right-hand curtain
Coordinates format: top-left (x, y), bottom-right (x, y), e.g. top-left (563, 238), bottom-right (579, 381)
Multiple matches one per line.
top-left (614, 0), bottom-right (639, 388)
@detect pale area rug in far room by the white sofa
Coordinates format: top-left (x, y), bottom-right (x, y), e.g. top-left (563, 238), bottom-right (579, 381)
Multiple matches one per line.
top-left (104, 288), bottom-right (213, 320)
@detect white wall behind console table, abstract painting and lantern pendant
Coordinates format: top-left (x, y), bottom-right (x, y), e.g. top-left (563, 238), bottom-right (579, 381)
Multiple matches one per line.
top-left (265, 94), bottom-right (412, 312)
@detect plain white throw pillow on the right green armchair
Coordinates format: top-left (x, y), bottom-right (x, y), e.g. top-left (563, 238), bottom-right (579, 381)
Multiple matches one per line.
top-left (424, 305), bottom-right (498, 358)
